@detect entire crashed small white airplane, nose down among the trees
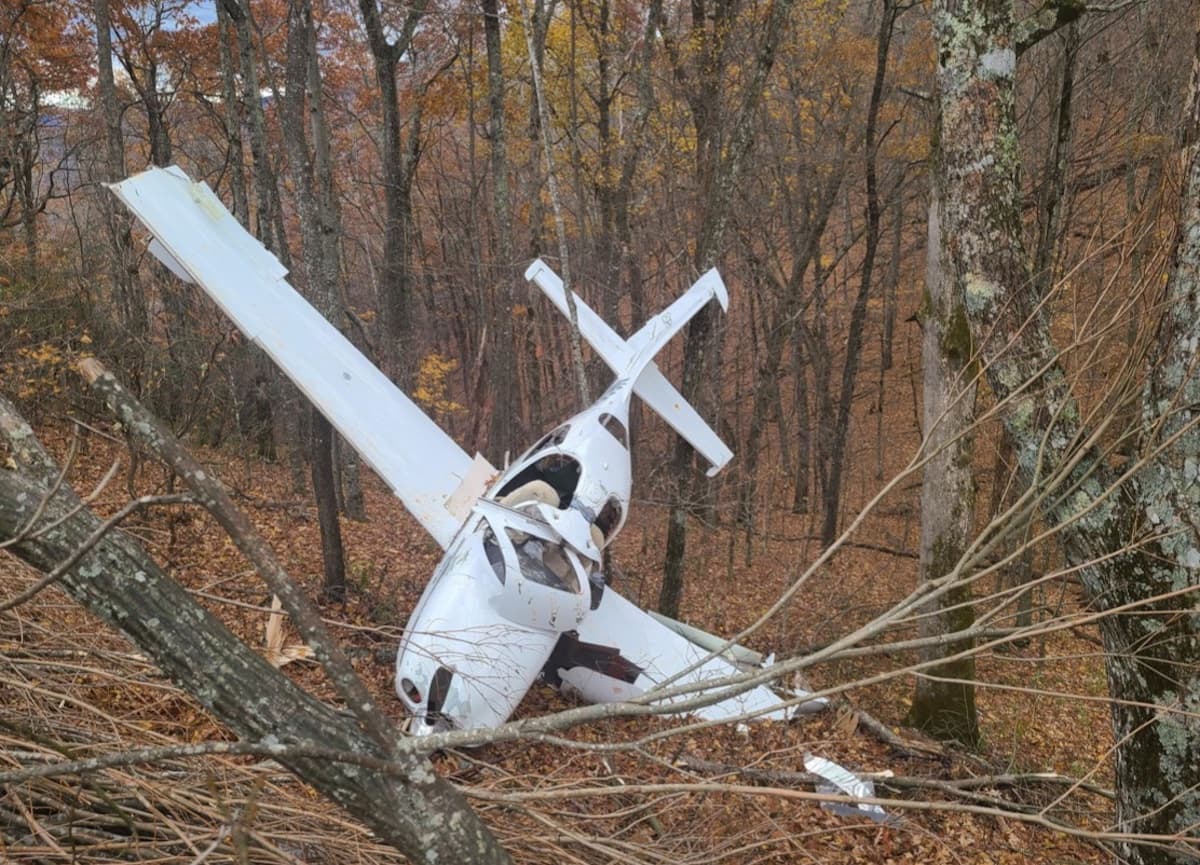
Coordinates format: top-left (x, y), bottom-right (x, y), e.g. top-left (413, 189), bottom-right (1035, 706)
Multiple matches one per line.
top-left (110, 167), bottom-right (824, 735)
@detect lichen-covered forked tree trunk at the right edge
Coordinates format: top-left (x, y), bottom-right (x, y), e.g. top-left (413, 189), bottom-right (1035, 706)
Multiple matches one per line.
top-left (934, 0), bottom-right (1200, 865)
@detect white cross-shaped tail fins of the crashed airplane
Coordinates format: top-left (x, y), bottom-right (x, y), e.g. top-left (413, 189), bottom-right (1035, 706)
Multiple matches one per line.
top-left (526, 258), bottom-right (733, 476)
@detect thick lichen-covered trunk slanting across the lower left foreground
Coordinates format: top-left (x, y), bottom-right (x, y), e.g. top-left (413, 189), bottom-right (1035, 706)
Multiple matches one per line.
top-left (0, 388), bottom-right (509, 863)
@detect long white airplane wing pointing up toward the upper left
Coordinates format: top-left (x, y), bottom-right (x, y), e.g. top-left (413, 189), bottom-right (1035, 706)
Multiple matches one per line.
top-left (109, 166), bottom-right (496, 548)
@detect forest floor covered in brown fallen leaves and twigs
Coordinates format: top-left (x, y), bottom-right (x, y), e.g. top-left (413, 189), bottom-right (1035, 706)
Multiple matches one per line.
top-left (0, 412), bottom-right (1111, 865)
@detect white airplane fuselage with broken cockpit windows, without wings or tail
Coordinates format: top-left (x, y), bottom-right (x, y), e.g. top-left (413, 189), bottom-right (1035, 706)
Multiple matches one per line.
top-left (396, 382), bottom-right (631, 734)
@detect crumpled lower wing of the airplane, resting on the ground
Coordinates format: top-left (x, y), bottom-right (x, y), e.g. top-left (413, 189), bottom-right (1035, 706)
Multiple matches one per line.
top-left (547, 587), bottom-right (826, 721)
